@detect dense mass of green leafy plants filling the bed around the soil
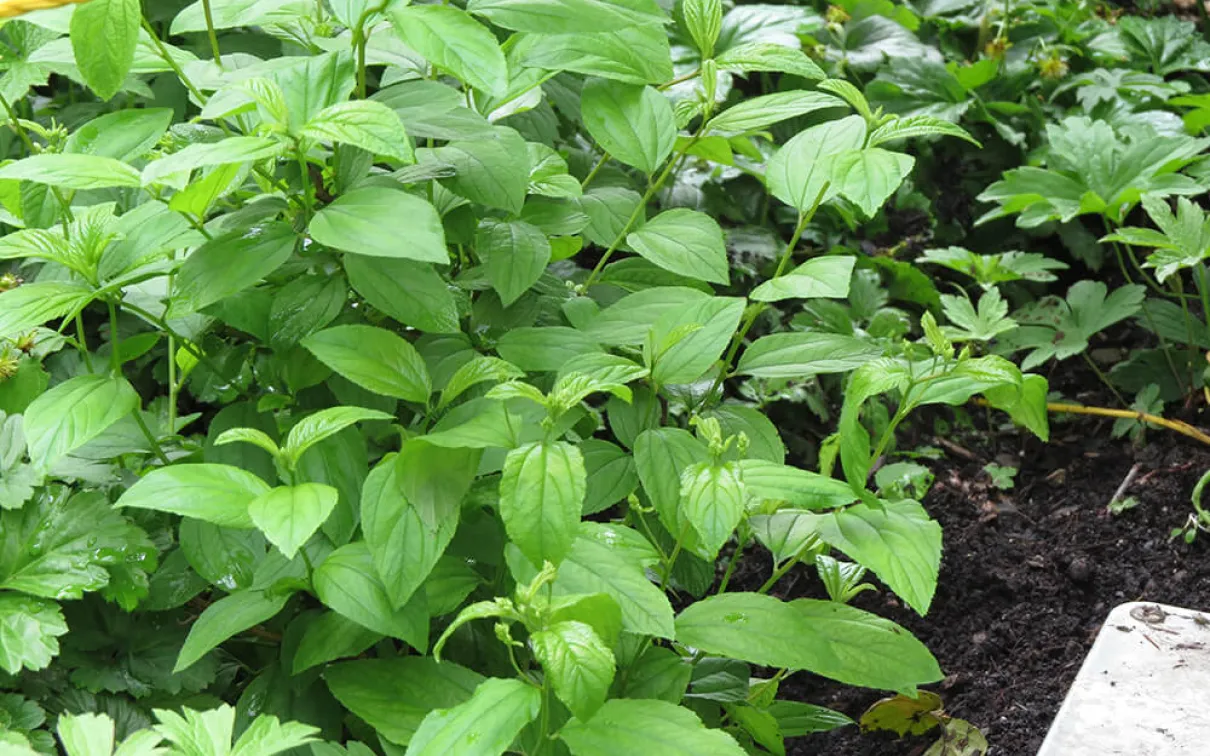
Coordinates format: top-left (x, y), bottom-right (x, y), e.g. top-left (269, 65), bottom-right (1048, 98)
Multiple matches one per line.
top-left (0, 0), bottom-right (1210, 756)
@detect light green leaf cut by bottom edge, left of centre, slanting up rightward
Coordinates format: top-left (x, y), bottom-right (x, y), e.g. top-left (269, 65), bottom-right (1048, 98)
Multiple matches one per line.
top-left (408, 677), bottom-right (542, 756)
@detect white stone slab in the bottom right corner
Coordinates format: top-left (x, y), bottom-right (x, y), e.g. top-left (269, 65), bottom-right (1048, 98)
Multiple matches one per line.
top-left (1038, 604), bottom-right (1210, 756)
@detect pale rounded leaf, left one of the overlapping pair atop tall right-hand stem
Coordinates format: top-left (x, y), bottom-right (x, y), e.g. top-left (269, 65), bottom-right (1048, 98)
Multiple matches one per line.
top-left (765, 115), bottom-right (865, 213)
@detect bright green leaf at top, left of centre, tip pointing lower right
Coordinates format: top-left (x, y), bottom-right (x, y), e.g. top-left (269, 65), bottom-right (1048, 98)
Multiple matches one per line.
top-left (388, 5), bottom-right (508, 97)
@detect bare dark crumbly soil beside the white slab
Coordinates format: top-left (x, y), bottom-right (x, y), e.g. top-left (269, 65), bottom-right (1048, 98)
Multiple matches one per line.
top-left (750, 420), bottom-right (1210, 756)
